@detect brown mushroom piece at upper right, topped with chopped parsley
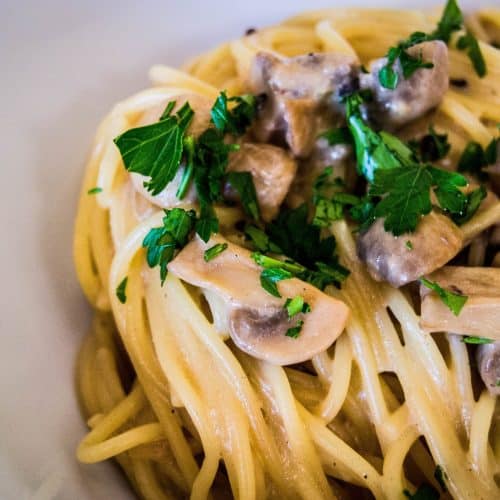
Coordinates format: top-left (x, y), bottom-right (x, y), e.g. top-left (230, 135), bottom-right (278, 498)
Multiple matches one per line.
top-left (360, 40), bottom-right (449, 127)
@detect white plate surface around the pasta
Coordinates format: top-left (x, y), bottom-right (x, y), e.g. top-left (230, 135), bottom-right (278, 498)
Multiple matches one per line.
top-left (0, 0), bottom-right (490, 500)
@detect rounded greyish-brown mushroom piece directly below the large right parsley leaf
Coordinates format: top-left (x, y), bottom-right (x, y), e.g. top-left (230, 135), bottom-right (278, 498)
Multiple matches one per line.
top-left (357, 212), bottom-right (463, 287)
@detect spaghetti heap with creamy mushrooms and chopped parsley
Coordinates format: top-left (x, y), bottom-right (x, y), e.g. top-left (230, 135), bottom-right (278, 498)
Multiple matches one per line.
top-left (74, 0), bottom-right (500, 500)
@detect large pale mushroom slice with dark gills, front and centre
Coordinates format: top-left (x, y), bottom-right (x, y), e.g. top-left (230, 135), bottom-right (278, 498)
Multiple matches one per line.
top-left (168, 236), bottom-right (349, 365)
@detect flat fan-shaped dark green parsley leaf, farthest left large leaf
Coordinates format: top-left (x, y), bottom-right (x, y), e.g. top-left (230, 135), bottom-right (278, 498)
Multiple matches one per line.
top-left (114, 101), bottom-right (194, 195)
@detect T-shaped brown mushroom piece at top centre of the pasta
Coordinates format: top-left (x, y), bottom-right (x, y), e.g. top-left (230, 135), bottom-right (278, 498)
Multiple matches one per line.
top-left (250, 52), bottom-right (359, 157)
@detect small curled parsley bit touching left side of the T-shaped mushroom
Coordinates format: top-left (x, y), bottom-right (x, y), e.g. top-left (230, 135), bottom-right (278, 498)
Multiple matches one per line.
top-left (211, 91), bottom-right (257, 135)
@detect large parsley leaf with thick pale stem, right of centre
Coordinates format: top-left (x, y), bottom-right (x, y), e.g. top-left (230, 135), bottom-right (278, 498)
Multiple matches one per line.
top-left (346, 94), bottom-right (483, 236)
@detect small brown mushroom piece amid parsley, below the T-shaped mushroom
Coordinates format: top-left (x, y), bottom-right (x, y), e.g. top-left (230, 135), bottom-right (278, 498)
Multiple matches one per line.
top-left (224, 143), bottom-right (297, 221)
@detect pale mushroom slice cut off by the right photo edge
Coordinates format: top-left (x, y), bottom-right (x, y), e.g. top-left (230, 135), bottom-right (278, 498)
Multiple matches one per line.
top-left (420, 266), bottom-right (500, 340)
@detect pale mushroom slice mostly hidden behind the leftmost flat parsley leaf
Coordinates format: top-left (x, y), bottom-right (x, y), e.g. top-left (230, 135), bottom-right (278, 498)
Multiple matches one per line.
top-left (131, 94), bottom-right (211, 208)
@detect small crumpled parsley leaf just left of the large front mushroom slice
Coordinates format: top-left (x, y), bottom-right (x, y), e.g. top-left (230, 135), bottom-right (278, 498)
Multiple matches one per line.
top-left (142, 208), bottom-right (196, 285)
